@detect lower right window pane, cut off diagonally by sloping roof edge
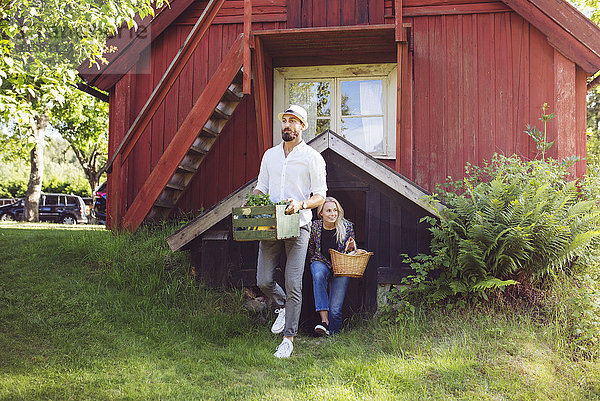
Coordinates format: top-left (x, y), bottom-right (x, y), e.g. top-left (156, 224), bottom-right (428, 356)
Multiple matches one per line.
top-left (341, 117), bottom-right (384, 153)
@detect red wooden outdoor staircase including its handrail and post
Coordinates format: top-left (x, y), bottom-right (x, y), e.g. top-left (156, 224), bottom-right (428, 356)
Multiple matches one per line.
top-left (102, 0), bottom-right (264, 231)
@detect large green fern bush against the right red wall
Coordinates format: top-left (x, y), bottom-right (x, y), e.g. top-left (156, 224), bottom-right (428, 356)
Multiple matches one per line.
top-left (406, 155), bottom-right (600, 302)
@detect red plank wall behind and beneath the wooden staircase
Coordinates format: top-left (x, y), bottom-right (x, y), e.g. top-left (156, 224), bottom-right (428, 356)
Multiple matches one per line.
top-left (109, 16), bottom-right (288, 222)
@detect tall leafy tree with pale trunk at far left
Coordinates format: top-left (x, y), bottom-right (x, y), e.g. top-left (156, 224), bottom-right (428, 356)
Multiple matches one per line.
top-left (0, 0), bottom-right (163, 221)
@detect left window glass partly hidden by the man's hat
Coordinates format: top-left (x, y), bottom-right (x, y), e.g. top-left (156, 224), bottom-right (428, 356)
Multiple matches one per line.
top-left (286, 81), bottom-right (331, 141)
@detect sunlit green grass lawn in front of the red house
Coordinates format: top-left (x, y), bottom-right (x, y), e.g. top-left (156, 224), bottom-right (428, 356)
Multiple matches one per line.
top-left (0, 223), bottom-right (600, 400)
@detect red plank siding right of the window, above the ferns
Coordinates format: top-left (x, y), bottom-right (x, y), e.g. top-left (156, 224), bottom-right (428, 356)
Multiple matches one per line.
top-left (410, 12), bottom-right (585, 190)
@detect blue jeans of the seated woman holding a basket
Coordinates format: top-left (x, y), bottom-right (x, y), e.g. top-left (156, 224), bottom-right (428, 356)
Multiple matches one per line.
top-left (310, 261), bottom-right (350, 333)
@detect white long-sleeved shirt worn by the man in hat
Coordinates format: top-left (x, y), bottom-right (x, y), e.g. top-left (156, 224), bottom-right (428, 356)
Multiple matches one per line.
top-left (256, 141), bottom-right (327, 227)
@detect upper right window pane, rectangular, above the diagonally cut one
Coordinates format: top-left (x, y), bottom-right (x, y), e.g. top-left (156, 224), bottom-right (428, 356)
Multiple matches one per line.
top-left (341, 79), bottom-right (383, 116)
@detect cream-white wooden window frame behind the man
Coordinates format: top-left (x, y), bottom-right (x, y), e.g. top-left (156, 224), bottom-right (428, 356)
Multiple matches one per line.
top-left (273, 64), bottom-right (398, 159)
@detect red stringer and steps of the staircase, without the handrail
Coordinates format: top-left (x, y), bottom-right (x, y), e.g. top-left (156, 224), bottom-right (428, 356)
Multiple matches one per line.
top-left (122, 35), bottom-right (243, 231)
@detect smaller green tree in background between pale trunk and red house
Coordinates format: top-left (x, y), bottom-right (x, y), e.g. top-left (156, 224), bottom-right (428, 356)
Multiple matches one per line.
top-left (52, 93), bottom-right (108, 197)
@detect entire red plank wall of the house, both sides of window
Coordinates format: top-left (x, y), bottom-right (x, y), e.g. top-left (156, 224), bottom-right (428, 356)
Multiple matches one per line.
top-left (109, 0), bottom-right (586, 227)
